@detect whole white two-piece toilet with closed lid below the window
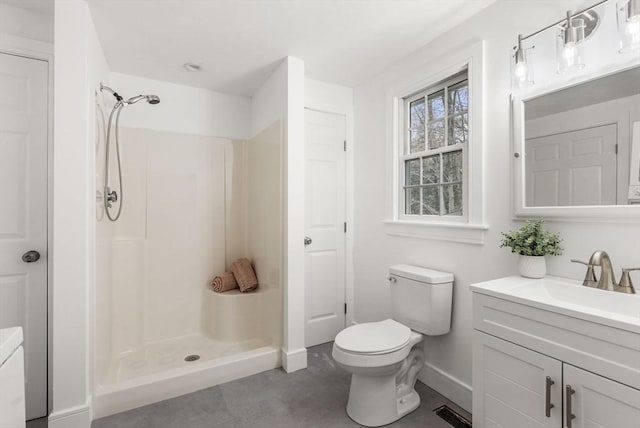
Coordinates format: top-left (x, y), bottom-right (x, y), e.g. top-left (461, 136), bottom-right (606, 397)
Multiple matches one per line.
top-left (333, 265), bottom-right (453, 427)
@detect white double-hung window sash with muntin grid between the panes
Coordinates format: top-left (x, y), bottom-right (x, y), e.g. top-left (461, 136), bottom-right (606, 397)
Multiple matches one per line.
top-left (397, 72), bottom-right (472, 223)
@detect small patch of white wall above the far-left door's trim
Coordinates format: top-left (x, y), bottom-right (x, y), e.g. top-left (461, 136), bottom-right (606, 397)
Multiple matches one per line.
top-left (0, 0), bottom-right (53, 43)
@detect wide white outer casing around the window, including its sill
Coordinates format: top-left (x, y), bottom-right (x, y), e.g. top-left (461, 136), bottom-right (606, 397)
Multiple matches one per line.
top-left (383, 40), bottom-right (489, 245)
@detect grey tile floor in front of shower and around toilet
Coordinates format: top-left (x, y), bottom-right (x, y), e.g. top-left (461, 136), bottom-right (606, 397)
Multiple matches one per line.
top-left (90, 343), bottom-right (471, 428)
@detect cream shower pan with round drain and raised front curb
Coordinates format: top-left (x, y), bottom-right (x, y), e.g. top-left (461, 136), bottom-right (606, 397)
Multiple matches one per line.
top-left (93, 335), bottom-right (281, 419)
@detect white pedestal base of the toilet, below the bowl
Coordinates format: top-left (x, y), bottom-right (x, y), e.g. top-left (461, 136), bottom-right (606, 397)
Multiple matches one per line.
top-left (347, 347), bottom-right (424, 427)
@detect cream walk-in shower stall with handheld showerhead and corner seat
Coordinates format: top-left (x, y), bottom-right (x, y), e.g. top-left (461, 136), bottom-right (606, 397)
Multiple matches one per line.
top-left (94, 82), bottom-right (283, 417)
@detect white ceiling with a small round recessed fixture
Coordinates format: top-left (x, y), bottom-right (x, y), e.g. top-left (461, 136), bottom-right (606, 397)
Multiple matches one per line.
top-left (89, 0), bottom-right (495, 95)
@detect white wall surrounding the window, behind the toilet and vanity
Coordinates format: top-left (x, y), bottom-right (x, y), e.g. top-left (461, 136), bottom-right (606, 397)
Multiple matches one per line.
top-left (354, 0), bottom-right (640, 409)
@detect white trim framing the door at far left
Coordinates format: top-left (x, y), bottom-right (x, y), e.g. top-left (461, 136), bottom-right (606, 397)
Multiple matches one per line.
top-left (0, 34), bottom-right (54, 416)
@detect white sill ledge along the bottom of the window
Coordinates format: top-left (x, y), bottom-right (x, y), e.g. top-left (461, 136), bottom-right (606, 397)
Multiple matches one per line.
top-left (384, 220), bottom-right (489, 245)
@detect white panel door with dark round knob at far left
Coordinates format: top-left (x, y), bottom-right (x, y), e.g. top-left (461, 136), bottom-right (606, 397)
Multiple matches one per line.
top-left (0, 54), bottom-right (49, 419)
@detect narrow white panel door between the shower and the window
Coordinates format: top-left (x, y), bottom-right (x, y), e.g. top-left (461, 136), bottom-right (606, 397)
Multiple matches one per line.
top-left (305, 110), bottom-right (346, 346)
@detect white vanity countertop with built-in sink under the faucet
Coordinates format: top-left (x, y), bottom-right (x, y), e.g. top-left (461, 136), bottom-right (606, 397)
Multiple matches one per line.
top-left (471, 276), bottom-right (640, 333)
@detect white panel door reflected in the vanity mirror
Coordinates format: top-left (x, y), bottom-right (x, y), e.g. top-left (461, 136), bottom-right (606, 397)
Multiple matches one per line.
top-left (525, 124), bottom-right (618, 207)
